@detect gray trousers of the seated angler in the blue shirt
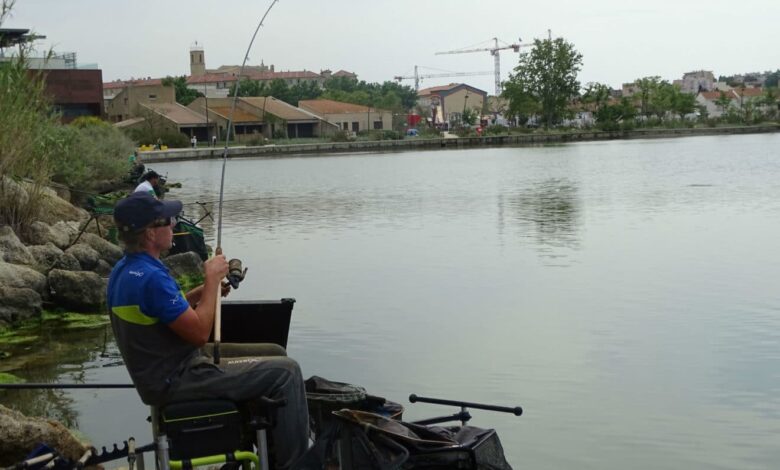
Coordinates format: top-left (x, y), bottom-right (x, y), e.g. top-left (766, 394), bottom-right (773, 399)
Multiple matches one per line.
top-left (166, 343), bottom-right (309, 469)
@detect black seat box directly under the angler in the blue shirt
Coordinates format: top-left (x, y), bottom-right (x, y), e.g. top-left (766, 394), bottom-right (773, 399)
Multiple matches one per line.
top-left (160, 400), bottom-right (242, 460)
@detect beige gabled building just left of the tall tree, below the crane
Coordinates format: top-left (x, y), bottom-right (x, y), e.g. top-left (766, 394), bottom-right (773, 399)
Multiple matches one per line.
top-left (417, 83), bottom-right (487, 125)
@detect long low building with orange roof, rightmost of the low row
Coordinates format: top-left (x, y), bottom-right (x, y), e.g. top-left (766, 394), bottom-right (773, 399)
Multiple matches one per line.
top-left (298, 99), bottom-right (393, 132)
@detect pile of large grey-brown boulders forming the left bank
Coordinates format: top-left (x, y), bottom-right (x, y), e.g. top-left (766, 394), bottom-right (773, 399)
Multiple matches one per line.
top-left (0, 179), bottom-right (202, 328)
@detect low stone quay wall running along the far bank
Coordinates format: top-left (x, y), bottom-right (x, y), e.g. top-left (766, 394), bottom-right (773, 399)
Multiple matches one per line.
top-left (141, 124), bottom-right (780, 163)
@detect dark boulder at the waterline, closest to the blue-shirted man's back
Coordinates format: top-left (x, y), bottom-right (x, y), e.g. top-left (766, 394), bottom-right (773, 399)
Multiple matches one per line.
top-left (48, 268), bottom-right (107, 313)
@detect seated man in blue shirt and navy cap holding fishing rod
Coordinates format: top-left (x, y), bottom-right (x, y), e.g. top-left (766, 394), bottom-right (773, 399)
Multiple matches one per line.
top-left (106, 192), bottom-right (309, 469)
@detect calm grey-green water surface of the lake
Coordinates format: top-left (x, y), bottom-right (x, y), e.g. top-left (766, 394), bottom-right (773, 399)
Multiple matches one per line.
top-left (1, 135), bottom-right (780, 469)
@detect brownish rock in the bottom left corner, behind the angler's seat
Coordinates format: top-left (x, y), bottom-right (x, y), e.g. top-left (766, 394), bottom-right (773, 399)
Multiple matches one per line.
top-left (0, 405), bottom-right (87, 467)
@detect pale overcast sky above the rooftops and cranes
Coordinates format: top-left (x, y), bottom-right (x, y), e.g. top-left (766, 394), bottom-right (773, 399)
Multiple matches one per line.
top-left (3, 0), bottom-right (780, 93)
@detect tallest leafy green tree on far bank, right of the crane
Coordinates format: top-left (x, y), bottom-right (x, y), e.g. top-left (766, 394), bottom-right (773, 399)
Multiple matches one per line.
top-left (503, 38), bottom-right (582, 128)
